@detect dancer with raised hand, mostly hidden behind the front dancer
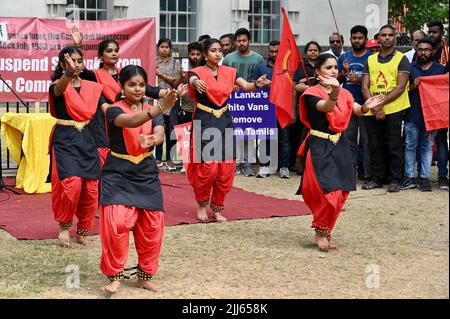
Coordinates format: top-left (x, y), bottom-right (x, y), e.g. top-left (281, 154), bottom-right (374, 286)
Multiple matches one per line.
top-left (71, 27), bottom-right (187, 167)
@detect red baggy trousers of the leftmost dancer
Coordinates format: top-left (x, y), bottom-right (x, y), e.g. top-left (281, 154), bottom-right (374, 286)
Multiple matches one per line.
top-left (51, 152), bottom-right (98, 229)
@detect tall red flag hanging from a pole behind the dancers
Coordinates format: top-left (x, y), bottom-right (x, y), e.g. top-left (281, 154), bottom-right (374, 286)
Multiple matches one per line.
top-left (269, 8), bottom-right (301, 128)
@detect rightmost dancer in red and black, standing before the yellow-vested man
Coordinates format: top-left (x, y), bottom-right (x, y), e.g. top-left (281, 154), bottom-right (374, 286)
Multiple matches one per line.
top-left (298, 54), bottom-right (384, 250)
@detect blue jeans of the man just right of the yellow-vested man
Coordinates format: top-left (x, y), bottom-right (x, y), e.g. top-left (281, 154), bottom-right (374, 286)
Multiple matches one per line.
top-left (405, 122), bottom-right (436, 178)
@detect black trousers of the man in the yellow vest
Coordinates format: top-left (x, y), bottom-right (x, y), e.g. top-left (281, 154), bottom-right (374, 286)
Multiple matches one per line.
top-left (364, 111), bottom-right (404, 184)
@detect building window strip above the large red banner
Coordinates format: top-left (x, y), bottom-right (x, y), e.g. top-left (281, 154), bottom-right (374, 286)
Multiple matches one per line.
top-left (66, 0), bottom-right (108, 20)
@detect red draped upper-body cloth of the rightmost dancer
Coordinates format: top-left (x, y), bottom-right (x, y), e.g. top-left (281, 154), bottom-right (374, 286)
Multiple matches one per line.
top-left (298, 85), bottom-right (355, 156)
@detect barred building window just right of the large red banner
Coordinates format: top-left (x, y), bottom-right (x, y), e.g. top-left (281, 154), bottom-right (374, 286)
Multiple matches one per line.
top-left (159, 0), bottom-right (197, 43)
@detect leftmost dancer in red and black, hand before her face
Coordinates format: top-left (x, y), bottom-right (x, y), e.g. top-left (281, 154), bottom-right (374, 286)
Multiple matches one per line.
top-left (49, 47), bottom-right (108, 247)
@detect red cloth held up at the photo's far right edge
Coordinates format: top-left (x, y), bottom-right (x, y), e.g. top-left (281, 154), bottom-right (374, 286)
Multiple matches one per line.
top-left (419, 74), bottom-right (449, 131)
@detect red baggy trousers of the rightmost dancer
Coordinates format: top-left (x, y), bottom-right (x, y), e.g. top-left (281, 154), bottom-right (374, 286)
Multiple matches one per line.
top-left (302, 152), bottom-right (349, 234)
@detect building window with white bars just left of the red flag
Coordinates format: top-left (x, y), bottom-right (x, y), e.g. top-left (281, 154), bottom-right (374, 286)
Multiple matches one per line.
top-left (248, 0), bottom-right (281, 43)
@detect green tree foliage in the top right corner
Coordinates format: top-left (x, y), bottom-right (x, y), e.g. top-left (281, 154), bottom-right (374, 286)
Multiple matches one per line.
top-left (389, 0), bottom-right (449, 35)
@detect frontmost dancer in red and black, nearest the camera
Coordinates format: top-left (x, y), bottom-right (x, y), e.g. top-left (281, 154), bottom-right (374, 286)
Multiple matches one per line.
top-left (100, 65), bottom-right (177, 293)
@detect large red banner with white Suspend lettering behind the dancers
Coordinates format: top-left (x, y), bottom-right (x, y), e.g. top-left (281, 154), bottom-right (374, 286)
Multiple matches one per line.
top-left (0, 17), bottom-right (156, 102)
